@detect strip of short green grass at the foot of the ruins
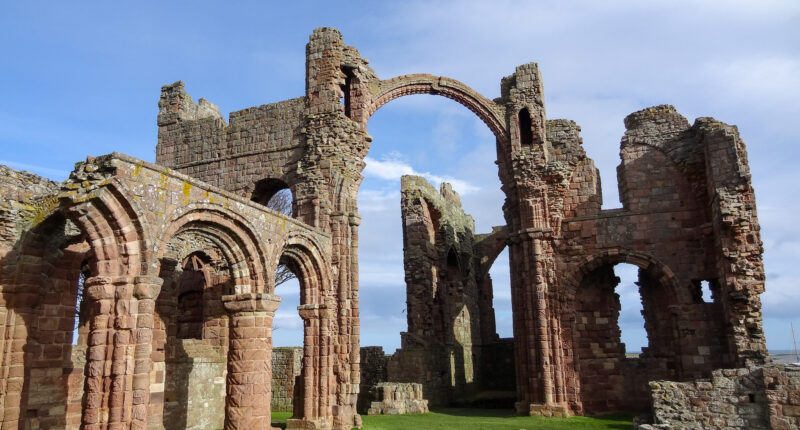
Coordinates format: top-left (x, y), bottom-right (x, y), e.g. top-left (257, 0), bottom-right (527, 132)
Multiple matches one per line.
top-left (272, 409), bottom-right (633, 430)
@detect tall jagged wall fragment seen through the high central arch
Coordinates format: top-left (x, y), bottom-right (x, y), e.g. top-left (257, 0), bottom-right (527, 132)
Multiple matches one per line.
top-left (388, 176), bottom-right (480, 404)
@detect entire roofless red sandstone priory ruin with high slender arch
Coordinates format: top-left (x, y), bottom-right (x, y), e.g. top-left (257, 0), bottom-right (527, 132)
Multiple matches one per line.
top-left (0, 28), bottom-right (800, 430)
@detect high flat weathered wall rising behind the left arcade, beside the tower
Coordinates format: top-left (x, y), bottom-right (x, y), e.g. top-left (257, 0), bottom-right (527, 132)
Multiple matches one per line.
top-left (156, 81), bottom-right (305, 203)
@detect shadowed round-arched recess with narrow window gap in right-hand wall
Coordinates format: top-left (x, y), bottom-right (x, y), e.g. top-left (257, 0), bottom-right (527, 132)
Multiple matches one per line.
top-left (561, 249), bottom-right (684, 413)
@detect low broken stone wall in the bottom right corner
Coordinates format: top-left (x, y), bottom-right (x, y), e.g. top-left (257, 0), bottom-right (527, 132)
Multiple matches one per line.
top-left (637, 364), bottom-right (800, 430)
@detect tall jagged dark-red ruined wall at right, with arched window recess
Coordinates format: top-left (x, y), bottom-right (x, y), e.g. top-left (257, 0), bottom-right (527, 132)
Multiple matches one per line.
top-left (555, 106), bottom-right (765, 411)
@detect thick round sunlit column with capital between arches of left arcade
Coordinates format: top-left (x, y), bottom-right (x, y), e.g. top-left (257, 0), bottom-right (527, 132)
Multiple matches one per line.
top-left (222, 293), bottom-right (281, 430)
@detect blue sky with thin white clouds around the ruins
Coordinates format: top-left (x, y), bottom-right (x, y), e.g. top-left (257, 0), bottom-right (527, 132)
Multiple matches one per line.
top-left (0, 0), bottom-right (800, 350)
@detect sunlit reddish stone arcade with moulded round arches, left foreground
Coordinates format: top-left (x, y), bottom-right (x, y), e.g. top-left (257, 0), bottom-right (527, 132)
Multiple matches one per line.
top-left (54, 154), bottom-right (335, 428)
